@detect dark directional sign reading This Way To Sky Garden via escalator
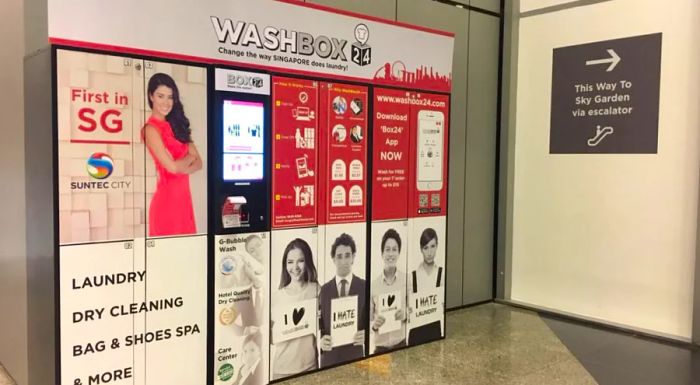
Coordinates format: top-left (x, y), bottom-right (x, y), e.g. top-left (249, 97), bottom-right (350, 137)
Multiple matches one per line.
top-left (549, 33), bottom-right (661, 154)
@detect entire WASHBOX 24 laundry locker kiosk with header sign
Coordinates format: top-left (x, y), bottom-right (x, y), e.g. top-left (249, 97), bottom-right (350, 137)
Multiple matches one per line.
top-left (27, 0), bottom-right (453, 385)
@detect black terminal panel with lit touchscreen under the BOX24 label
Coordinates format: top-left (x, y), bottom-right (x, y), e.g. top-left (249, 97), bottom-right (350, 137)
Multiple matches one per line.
top-left (211, 68), bottom-right (271, 234)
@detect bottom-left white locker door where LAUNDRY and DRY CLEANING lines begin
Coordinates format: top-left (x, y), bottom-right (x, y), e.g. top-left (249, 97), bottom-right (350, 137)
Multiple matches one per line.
top-left (59, 241), bottom-right (139, 384)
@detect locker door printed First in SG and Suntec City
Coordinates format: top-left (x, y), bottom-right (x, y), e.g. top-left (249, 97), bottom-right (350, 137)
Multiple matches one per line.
top-left (56, 50), bottom-right (143, 244)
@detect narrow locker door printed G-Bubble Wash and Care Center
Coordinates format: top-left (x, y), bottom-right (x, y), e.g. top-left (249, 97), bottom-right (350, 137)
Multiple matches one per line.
top-left (211, 232), bottom-right (270, 385)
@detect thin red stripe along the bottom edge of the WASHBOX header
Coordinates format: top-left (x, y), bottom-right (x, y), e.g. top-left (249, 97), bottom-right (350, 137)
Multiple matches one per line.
top-left (49, 37), bottom-right (449, 92)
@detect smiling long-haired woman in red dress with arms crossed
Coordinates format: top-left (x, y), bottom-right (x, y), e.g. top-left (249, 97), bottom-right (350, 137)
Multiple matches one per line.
top-left (143, 73), bottom-right (202, 236)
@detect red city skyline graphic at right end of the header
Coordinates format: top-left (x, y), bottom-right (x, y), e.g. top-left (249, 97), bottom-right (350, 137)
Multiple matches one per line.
top-left (374, 61), bottom-right (452, 91)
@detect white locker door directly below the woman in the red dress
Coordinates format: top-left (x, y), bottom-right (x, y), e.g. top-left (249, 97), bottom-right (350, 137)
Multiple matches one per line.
top-left (142, 235), bottom-right (207, 385)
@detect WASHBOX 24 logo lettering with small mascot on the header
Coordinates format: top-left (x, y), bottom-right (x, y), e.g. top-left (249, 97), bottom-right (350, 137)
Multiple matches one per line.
top-left (210, 16), bottom-right (372, 66)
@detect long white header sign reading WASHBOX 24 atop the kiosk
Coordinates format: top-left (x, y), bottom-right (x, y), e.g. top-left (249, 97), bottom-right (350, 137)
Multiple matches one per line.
top-left (49, 0), bottom-right (454, 92)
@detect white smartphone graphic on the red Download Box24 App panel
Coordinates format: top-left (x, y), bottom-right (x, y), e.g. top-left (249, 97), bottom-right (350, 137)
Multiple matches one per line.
top-left (416, 110), bottom-right (445, 191)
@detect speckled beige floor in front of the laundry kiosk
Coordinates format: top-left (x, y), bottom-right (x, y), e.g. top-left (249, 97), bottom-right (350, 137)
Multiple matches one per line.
top-left (282, 304), bottom-right (596, 385)
